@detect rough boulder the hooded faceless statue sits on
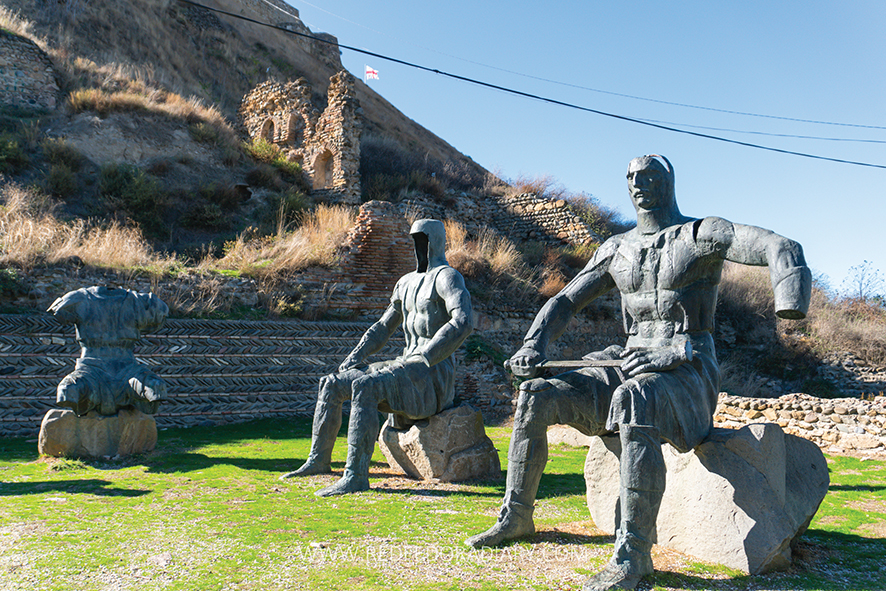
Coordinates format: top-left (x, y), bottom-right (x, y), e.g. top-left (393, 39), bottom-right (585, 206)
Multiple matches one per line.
top-left (378, 405), bottom-right (501, 482)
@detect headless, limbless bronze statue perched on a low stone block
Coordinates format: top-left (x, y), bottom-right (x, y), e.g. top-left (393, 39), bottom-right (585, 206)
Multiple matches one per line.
top-left (49, 287), bottom-right (169, 416)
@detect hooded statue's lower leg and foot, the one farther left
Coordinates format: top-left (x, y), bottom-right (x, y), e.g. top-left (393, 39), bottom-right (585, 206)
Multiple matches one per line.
top-left (280, 374), bottom-right (354, 478)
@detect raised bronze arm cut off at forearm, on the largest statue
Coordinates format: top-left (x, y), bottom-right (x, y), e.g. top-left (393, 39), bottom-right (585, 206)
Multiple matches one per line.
top-left (705, 220), bottom-right (812, 320)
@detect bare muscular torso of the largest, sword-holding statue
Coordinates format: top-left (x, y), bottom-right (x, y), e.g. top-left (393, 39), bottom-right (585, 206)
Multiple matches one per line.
top-left (609, 220), bottom-right (723, 346)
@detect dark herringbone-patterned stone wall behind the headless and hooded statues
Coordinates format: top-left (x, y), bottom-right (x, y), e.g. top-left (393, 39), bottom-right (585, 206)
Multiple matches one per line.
top-left (0, 315), bottom-right (403, 436)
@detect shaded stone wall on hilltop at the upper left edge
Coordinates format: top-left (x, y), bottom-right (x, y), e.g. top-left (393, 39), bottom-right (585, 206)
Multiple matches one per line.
top-left (0, 29), bottom-right (59, 110)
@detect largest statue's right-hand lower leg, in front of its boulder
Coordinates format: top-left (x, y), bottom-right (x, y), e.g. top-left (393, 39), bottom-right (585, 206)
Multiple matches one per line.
top-left (582, 424), bottom-right (665, 591)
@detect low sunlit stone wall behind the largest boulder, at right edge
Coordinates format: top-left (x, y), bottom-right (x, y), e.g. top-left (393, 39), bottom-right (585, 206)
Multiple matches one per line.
top-left (714, 394), bottom-right (886, 454)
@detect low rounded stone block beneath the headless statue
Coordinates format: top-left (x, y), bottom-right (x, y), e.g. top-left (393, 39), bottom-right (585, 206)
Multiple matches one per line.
top-left (37, 409), bottom-right (157, 458)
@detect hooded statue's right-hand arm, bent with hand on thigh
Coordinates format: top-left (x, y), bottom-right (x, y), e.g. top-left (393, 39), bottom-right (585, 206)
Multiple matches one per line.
top-left (415, 268), bottom-right (474, 367)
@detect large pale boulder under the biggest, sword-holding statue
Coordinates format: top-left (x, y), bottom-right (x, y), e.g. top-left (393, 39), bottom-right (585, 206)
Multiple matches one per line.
top-left (585, 423), bottom-right (830, 574)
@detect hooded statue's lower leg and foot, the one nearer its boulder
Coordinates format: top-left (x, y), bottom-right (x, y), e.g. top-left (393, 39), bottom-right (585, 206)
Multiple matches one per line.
top-left (315, 376), bottom-right (379, 497)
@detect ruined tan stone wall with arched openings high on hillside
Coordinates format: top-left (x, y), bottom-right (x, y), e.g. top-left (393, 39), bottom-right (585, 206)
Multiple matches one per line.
top-left (240, 71), bottom-right (361, 205)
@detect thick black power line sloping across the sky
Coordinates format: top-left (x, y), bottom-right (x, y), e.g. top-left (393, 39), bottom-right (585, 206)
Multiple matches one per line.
top-left (179, 0), bottom-right (886, 169)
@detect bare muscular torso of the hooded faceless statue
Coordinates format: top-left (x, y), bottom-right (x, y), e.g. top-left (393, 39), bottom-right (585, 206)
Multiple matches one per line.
top-left (397, 268), bottom-right (450, 356)
